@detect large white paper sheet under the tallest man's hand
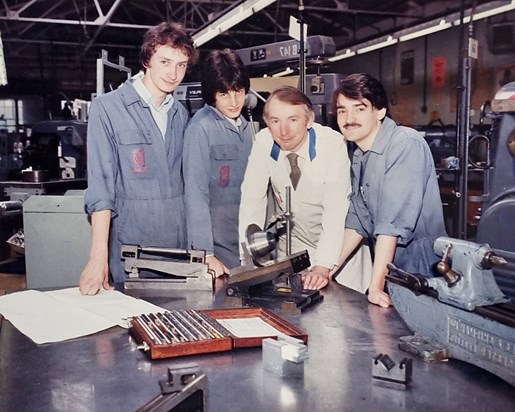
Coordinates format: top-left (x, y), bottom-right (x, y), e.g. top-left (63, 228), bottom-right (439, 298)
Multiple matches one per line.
top-left (0, 288), bottom-right (165, 344)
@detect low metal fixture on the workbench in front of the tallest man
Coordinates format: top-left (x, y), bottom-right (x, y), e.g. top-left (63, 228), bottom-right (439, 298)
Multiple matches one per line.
top-left (121, 245), bottom-right (215, 290)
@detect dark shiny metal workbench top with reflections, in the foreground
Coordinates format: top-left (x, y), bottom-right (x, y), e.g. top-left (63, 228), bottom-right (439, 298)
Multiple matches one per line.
top-left (0, 283), bottom-right (515, 412)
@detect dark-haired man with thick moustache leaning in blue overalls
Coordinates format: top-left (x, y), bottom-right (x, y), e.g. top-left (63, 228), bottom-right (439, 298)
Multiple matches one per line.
top-left (306, 74), bottom-right (445, 307)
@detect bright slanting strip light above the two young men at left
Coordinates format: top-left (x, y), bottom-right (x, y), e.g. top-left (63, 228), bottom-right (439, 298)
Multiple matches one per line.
top-left (193, 0), bottom-right (276, 47)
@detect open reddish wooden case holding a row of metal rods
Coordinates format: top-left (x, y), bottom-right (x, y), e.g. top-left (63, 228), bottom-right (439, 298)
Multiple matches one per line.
top-left (129, 308), bottom-right (308, 359)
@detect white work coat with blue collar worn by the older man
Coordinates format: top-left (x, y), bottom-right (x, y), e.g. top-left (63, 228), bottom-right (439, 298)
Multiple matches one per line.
top-left (239, 123), bottom-right (351, 269)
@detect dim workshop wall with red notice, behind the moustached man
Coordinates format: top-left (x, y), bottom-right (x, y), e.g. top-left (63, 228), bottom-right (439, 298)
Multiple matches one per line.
top-left (331, 13), bottom-right (515, 125)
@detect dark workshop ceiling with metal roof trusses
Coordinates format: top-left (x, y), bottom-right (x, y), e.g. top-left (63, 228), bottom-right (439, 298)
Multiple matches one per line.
top-left (0, 0), bottom-right (500, 97)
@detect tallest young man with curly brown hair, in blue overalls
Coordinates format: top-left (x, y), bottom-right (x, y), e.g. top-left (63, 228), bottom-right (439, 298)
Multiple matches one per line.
top-left (79, 23), bottom-right (197, 295)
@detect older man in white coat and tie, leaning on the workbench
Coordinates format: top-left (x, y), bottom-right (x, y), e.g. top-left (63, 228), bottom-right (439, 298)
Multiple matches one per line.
top-left (239, 86), bottom-right (350, 279)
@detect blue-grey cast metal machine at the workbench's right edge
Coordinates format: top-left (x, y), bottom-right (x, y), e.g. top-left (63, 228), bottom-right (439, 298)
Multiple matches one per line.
top-left (387, 237), bottom-right (515, 386)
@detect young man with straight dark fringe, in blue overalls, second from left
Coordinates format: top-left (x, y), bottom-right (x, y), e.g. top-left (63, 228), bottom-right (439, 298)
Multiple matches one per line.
top-left (183, 49), bottom-right (253, 276)
